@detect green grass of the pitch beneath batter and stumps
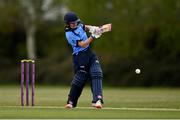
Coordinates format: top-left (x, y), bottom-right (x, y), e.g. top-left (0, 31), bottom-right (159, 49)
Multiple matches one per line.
top-left (0, 86), bottom-right (180, 119)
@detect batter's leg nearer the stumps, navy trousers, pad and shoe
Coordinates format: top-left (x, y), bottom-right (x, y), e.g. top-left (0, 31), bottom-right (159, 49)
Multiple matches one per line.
top-left (67, 52), bottom-right (88, 107)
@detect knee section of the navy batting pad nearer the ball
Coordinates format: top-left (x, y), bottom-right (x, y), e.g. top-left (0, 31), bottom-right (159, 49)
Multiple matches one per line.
top-left (90, 61), bottom-right (103, 79)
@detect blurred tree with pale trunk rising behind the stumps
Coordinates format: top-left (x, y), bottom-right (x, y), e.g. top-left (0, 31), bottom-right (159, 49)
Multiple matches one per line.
top-left (19, 0), bottom-right (68, 59)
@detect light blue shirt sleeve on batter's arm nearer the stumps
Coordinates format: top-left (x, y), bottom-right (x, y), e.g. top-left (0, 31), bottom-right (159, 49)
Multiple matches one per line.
top-left (66, 32), bottom-right (80, 46)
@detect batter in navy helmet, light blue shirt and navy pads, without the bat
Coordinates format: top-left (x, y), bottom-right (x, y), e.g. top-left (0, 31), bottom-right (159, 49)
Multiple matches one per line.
top-left (64, 12), bottom-right (103, 108)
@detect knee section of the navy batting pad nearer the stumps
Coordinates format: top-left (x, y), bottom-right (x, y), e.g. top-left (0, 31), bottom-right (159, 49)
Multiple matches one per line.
top-left (71, 70), bottom-right (87, 87)
